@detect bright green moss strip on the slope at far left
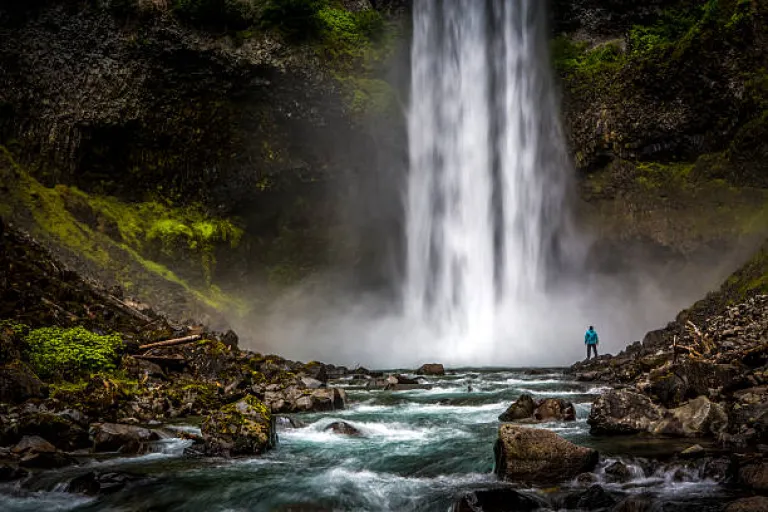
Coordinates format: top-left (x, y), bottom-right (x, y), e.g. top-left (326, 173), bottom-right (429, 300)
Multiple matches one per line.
top-left (0, 146), bottom-right (245, 311)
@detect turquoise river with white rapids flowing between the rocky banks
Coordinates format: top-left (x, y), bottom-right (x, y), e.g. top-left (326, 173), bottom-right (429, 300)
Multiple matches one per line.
top-left (0, 370), bottom-right (736, 512)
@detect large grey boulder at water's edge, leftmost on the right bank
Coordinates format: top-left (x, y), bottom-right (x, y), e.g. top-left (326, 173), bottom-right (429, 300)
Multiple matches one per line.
top-left (587, 389), bottom-right (666, 435)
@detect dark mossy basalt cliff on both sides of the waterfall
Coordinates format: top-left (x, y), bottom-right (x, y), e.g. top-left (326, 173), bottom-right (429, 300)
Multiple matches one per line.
top-left (0, 0), bottom-right (768, 324)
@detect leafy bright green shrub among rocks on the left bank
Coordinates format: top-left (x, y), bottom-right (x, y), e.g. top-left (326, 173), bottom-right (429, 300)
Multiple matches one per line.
top-left (25, 327), bottom-right (123, 380)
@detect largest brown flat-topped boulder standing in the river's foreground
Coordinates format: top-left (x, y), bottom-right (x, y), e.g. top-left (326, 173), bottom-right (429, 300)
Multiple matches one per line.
top-left (494, 423), bottom-right (599, 485)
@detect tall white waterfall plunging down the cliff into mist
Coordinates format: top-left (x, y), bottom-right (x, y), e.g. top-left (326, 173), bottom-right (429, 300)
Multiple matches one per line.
top-left (405, 0), bottom-right (568, 358)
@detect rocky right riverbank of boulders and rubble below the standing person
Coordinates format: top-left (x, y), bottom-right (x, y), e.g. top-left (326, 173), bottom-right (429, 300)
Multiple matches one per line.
top-left (570, 295), bottom-right (768, 502)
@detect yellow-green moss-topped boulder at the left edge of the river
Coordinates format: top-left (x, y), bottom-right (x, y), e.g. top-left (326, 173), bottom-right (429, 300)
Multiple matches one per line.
top-left (201, 395), bottom-right (277, 456)
